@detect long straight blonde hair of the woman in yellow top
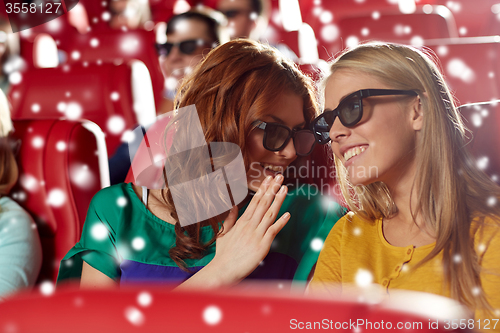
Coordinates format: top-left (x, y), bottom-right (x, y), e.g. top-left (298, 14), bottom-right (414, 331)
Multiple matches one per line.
top-left (326, 43), bottom-right (500, 310)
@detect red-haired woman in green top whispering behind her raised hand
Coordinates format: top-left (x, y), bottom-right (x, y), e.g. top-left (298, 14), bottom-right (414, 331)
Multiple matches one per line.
top-left (55, 40), bottom-right (343, 287)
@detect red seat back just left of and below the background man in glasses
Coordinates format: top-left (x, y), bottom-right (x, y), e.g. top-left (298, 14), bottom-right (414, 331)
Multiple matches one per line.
top-left (9, 63), bottom-right (155, 154)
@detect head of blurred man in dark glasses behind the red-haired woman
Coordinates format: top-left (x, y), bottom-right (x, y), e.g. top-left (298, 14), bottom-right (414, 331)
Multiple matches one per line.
top-left (156, 7), bottom-right (229, 114)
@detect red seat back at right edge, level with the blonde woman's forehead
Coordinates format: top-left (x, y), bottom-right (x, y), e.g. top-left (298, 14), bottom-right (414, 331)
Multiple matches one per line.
top-left (426, 36), bottom-right (500, 104)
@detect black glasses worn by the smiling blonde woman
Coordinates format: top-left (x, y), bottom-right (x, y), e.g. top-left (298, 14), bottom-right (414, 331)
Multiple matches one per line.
top-left (311, 89), bottom-right (418, 145)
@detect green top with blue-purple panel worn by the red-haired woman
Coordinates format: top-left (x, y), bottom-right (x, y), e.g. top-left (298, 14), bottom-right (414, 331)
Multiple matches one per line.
top-left (58, 183), bottom-right (345, 284)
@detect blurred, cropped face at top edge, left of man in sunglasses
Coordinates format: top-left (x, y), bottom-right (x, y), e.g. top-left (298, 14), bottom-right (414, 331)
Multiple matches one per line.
top-left (109, 0), bottom-right (151, 30)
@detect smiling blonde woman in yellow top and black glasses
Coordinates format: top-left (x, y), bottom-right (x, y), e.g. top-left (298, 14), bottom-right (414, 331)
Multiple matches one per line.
top-left (311, 43), bottom-right (500, 329)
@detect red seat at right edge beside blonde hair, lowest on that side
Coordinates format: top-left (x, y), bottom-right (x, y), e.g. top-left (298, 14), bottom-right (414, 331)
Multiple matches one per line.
top-left (460, 101), bottom-right (500, 183)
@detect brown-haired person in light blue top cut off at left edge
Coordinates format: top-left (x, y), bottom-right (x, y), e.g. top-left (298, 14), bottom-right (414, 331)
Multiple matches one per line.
top-left (0, 92), bottom-right (42, 300)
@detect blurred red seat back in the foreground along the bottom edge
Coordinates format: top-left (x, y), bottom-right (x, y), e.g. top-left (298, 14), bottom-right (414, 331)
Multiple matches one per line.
top-left (0, 286), bottom-right (472, 333)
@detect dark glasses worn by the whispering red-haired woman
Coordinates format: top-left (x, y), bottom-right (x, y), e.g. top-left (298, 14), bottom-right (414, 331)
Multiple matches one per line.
top-left (256, 121), bottom-right (316, 156)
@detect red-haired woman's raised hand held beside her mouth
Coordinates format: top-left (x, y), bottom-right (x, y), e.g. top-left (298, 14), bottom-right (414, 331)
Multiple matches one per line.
top-left (179, 175), bottom-right (290, 289)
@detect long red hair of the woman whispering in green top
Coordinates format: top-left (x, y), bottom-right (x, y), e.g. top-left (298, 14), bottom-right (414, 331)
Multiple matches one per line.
top-left (163, 40), bottom-right (318, 269)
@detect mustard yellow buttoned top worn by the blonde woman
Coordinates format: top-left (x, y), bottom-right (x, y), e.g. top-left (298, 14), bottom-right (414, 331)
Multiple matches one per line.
top-left (310, 213), bottom-right (500, 332)
